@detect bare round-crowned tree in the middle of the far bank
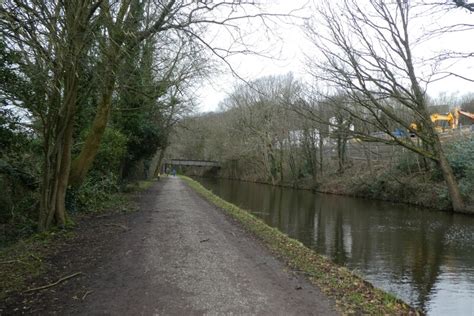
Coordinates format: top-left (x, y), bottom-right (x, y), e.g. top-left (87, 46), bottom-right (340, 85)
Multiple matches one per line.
top-left (220, 74), bottom-right (300, 184)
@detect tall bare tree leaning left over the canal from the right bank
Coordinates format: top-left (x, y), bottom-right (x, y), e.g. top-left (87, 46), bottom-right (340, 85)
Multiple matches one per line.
top-left (306, 0), bottom-right (468, 212)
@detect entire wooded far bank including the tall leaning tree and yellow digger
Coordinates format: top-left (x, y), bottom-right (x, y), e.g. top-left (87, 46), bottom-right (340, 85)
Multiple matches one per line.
top-left (169, 0), bottom-right (474, 213)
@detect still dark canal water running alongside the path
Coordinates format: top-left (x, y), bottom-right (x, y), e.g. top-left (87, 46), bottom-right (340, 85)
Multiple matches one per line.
top-left (196, 178), bottom-right (474, 315)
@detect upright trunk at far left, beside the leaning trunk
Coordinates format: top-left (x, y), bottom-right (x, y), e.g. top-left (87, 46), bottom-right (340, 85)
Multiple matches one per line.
top-left (38, 1), bottom-right (97, 231)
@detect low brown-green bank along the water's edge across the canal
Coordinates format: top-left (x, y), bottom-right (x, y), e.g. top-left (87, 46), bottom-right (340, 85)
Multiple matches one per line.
top-left (209, 165), bottom-right (464, 211)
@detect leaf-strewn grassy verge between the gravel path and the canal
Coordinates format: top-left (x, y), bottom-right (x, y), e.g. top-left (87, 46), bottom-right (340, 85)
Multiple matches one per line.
top-left (183, 177), bottom-right (417, 315)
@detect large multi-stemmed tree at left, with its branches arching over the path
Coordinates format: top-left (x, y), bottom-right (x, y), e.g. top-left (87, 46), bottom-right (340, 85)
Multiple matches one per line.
top-left (0, 0), bottom-right (284, 230)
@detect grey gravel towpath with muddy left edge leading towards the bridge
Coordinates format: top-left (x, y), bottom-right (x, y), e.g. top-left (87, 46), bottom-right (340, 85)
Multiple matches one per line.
top-left (3, 178), bottom-right (335, 315)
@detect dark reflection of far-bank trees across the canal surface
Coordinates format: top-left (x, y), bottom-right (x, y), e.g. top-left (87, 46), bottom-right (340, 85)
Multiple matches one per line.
top-left (201, 180), bottom-right (474, 308)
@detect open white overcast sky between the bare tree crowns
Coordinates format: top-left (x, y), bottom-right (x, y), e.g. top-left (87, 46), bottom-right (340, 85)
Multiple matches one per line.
top-left (193, 0), bottom-right (474, 112)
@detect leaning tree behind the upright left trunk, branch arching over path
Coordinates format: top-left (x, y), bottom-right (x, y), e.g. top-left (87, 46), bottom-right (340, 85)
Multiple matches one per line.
top-left (69, 0), bottom-right (286, 186)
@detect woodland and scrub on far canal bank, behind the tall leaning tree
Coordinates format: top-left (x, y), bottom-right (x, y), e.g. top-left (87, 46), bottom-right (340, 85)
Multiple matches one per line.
top-left (167, 74), bottom-right (474, 211)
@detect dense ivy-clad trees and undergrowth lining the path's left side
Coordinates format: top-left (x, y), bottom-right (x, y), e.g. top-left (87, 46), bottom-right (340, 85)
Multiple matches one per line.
top-left (0, 0), bottom-right (286, 244)
